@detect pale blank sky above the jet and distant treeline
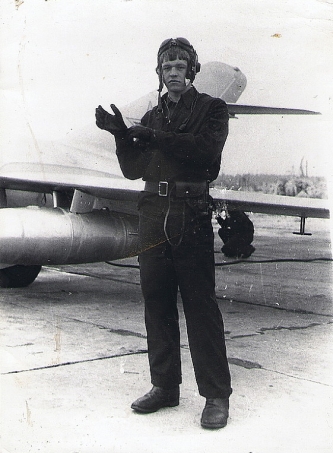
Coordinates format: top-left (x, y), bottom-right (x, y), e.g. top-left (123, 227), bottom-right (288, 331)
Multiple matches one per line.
top-left (0, 0), bottom-right (333, 177)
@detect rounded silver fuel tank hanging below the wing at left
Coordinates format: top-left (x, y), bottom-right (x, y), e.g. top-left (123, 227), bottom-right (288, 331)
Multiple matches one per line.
top-left (0, 206), bottom-right (138, 265)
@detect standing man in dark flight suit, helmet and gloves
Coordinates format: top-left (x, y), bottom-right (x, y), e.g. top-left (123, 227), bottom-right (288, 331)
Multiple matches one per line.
top-left (96, 38), bottom-right (232, 429)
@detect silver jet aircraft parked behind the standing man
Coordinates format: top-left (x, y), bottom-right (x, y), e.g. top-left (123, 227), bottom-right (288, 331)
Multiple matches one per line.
top-left (0, 62), bottom-right (329, 287)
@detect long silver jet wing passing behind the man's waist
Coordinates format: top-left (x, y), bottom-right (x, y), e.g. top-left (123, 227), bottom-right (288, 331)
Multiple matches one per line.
top-left (0, 164), bottom-right (329, 218)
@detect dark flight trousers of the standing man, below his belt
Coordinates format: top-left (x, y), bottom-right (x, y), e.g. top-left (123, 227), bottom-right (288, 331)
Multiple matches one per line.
top-left (139, 195), bottom-right (232, 398)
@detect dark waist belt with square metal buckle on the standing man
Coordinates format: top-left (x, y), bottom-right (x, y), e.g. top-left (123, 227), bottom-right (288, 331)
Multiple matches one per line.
top-left (144, 181), bottom-right (209, 198)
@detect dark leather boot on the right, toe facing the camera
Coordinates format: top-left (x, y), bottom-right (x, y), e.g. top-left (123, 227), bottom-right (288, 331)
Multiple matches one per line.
top-left (201, 398), bottom-right (229, 429)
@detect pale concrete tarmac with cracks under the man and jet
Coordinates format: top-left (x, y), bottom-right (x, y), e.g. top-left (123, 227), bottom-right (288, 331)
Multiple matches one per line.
top-left (0, 214), bottom-right (333, 453)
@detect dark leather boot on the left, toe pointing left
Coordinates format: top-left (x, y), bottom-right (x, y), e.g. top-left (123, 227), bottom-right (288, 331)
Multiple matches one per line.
top-left (131, 386), bottom-right (179, 414)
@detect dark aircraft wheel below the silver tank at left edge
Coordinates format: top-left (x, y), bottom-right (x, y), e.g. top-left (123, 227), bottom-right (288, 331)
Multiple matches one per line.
top-left (0, 264), bottom-right (42, 288)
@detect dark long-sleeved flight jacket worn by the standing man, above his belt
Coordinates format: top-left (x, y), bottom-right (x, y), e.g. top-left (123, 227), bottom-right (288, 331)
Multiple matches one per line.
top-left (116, 87), bottom-right (229, 182)
